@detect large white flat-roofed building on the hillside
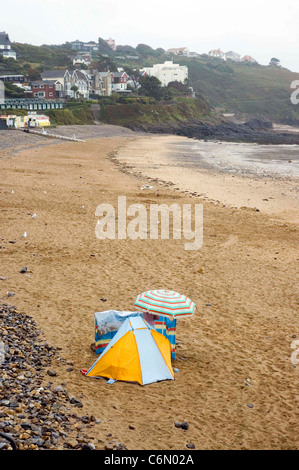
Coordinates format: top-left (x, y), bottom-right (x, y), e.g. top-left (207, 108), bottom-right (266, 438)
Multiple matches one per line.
top-left (140, 60), bottom-right (188, 86)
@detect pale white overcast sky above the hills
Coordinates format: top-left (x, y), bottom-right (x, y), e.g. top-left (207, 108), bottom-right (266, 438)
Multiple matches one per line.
top-left (0, 0), bottom-right (299, 72)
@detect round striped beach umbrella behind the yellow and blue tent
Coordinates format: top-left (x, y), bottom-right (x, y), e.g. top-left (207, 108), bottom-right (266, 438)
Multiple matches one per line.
top-left (134, 289), bottom-right (196, 319)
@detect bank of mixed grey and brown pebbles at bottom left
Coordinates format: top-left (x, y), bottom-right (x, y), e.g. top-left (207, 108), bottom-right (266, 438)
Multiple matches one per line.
top-left (0, 304), bottom-right (99, 450)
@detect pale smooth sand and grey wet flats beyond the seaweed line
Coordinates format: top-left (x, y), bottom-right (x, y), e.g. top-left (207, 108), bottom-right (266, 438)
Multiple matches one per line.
top-left (117, 136), bottom-right (299, 223)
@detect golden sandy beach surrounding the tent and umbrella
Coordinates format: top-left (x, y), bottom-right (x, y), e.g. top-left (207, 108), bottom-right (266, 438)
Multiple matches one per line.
top-left (0, 126), bottom-right (299, 450)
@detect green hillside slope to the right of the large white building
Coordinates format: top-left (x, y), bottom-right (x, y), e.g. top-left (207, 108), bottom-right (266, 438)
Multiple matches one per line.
top-left (173, 57), bottom-right (299, 121)
